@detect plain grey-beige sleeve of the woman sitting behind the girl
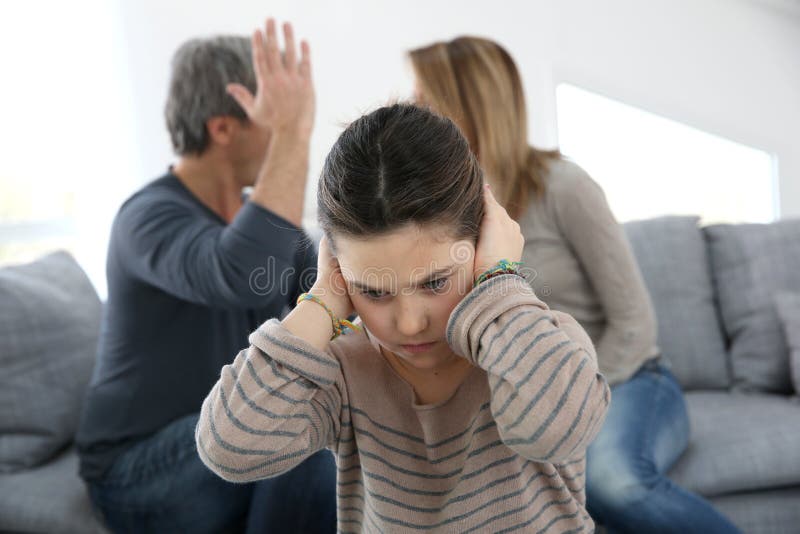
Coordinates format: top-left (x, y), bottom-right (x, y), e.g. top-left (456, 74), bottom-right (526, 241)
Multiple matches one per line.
top-left (553, 165), bottom-right (658, 384)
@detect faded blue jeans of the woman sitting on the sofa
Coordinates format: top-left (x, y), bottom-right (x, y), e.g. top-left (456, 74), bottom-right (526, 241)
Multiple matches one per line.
top-left (586, 361), bottom-right (739, 534)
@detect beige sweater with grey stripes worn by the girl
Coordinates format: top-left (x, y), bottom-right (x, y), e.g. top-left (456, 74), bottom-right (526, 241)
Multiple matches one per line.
top-left (195, 275), bottom-right (610, 533)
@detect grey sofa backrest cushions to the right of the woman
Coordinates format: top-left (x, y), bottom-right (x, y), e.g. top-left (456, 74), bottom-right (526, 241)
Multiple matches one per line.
top-left (623, 216), bottom-right (800, 394)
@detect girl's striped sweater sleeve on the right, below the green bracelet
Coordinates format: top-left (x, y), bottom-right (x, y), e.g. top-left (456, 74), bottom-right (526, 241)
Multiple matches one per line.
top-left (447, 275), bottom-right (611, 463)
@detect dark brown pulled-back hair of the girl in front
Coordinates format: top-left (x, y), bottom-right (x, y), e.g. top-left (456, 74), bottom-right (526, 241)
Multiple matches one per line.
top-left (317, 104), bottom-right (483, 244)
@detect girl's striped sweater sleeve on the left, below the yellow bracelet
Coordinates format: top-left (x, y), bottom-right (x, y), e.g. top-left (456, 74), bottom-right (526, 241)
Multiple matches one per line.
top-left (195, 319), bottom-right (345, 482)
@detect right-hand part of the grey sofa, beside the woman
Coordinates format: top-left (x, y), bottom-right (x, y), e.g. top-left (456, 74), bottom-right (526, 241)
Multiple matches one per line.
top-left (624, 217), bottom-right (800, 534)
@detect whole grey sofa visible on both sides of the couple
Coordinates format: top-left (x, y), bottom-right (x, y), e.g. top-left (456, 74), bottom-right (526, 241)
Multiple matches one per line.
top-left (0, 217), bottom-right (800, 534)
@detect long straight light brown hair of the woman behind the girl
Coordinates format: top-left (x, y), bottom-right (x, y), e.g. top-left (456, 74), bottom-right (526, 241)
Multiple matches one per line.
top-left (409, 37), bottom-right (561, 219)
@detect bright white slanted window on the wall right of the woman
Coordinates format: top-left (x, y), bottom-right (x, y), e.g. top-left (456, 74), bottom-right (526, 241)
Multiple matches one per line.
top-left (556, 84), bottom-right (779, 224)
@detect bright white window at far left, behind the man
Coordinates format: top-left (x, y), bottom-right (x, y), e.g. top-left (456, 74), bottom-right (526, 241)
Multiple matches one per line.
top-left (0, 0), bottom-right (137, 297)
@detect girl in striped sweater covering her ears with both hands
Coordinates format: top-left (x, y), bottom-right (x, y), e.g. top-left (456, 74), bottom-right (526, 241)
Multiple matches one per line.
top-left (196, 36), bottom-right (609, 532)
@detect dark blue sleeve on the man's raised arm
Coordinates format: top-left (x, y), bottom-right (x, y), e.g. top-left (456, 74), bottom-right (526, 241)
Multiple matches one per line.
top-left (114, 196), bottom-right (314, 309)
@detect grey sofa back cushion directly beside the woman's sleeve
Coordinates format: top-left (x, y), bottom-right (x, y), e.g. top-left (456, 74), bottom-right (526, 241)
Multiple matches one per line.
top-left (624, 216), bottom-right (730, 389)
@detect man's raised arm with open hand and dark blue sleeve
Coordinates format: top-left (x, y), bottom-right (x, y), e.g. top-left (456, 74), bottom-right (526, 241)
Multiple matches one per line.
top-left (115, 19), bottom-right (314, 308)
